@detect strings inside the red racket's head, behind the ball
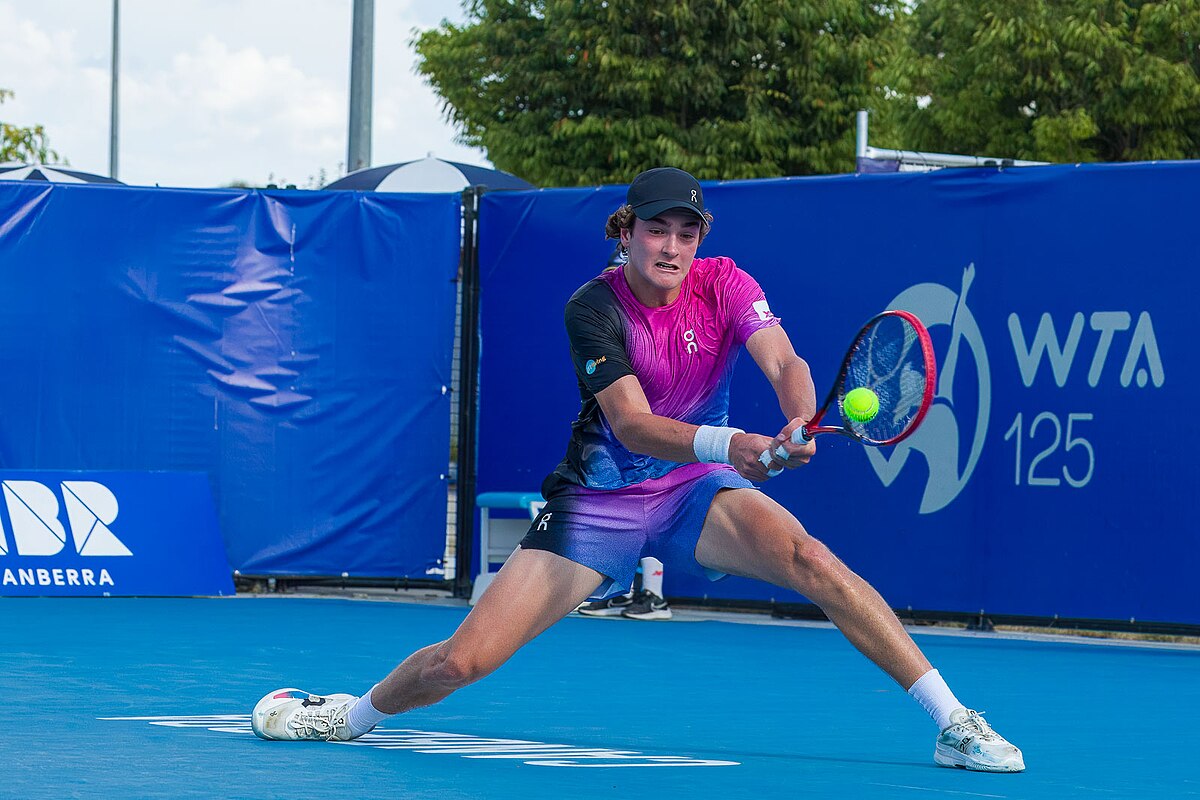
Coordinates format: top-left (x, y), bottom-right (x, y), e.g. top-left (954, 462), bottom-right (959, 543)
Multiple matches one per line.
top-left (839, 317), bottom-right (930, 441)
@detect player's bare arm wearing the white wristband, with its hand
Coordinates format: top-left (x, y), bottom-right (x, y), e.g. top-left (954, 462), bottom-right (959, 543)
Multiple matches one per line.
top-left (595, 375), bottom-right (773, 481)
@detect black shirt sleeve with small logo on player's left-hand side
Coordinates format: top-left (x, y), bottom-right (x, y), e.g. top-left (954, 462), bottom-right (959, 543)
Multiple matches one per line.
top-left (565, 285), bottom-right (635, 395)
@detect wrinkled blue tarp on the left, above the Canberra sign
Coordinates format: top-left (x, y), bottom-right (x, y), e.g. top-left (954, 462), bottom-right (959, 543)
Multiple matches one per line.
top-left (0, 184), bottom-right (461, 577)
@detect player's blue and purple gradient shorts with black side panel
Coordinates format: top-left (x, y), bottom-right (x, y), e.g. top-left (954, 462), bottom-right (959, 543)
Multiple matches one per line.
top-left (521, 464), bottom-right (756, 597)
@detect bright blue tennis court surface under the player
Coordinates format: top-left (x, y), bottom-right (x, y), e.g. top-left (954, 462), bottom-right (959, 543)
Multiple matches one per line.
top-left (0, 596), bottom-right (1200, 800)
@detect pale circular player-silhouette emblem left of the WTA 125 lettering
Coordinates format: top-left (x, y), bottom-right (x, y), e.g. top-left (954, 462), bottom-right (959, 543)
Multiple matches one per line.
top-left (866, 264), bottom-right (991, 513)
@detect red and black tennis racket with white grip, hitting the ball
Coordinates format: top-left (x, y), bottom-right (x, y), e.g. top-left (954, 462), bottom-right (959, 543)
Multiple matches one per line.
top-left (758, 311), bottom-right (937, 477)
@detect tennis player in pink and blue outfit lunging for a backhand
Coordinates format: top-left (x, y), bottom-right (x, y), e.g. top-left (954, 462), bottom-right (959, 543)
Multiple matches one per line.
top-left (252, 168), bottom-right (1025, 772)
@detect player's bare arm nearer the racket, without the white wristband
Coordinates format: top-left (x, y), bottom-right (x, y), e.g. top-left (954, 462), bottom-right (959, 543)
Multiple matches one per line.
top-left (746, 325), bottom-right (817, 467)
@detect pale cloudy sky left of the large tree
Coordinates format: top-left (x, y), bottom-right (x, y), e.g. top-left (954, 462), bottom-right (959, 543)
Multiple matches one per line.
top-left (0, 0), bottom-right (490, 188)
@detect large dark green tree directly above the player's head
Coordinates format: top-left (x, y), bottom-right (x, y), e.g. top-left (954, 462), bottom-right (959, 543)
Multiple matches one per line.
top-left (414, 0), bottom-right (895, 186)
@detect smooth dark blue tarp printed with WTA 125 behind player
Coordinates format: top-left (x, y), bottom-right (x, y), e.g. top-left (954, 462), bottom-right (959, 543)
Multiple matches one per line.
top-left (479, 163), bottom-right (1200, 624)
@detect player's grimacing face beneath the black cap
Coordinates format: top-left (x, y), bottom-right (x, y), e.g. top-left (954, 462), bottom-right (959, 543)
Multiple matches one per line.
top-left (620, 210), bottom-right (701, 306)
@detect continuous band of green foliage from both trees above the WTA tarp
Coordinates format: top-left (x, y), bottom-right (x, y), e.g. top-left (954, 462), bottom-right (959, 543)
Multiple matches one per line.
top-left (414, 0), bottom-right (1200, 179)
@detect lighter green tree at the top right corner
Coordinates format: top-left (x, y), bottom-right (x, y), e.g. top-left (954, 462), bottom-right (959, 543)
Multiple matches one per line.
top-left (872, 0), bottom-right (1200, 162)
